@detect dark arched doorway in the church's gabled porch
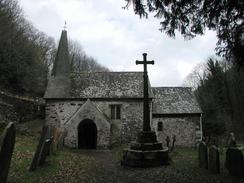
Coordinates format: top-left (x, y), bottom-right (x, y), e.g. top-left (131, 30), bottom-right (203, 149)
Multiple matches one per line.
top-left (78, 119), bottom-right (97, 149)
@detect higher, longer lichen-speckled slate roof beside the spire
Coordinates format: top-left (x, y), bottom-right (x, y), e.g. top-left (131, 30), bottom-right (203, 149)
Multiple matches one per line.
top-left (44, 72), bottom-right (153, 99)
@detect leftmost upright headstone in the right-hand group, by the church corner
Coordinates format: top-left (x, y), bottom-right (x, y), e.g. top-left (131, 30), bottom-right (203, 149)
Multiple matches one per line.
top-left (198, 142), bottom-right (208, 169)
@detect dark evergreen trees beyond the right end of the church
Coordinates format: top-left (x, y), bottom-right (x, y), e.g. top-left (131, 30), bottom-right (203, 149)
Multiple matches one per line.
top-left (192, 59), bottom-right (244, 138)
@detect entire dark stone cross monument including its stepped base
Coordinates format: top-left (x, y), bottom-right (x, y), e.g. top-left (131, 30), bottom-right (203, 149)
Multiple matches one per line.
top-left (121, 53), bottom-right (169, 167)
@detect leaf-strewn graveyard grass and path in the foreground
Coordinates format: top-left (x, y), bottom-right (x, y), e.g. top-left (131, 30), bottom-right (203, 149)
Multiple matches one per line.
top-left (2, 120), bottom-right (244, 183)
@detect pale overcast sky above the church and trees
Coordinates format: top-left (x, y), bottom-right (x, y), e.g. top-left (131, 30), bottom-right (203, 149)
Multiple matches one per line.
top-left (19, 0), bottom-right (217, 86)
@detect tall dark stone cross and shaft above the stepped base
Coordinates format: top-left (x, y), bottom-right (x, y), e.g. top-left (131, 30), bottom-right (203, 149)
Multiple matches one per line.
top-left (136, 53), bottom-right (154, 131)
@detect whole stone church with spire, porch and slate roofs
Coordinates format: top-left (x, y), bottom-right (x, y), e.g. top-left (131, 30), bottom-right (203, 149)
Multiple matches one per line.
top-left (44, 30), bottom-right (202, 149)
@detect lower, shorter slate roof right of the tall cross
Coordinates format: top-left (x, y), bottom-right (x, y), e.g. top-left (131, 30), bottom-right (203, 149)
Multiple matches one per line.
top-left (152, 87), bottom-right (202, 114)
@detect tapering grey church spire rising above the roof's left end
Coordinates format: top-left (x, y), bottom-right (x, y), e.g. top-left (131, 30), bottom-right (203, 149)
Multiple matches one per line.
top-left (52, 29), bottom-right (70, 76)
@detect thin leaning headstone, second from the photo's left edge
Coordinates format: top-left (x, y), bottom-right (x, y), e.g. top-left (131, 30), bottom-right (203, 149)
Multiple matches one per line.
top-left (29, 125), bottom-right (48, 171)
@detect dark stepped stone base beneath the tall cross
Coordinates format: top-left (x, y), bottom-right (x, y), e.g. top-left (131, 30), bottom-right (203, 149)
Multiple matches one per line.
top-left (121, 131), bottom-right (169, 168)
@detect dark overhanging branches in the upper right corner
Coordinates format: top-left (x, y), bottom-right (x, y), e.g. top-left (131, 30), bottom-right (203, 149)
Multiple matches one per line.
top-left (125, 0), bottom-right (244, 67)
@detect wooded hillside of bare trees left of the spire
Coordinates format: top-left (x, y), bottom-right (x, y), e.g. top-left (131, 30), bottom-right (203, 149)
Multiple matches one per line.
top-left (0, 0), bottom-right (55, 97)
